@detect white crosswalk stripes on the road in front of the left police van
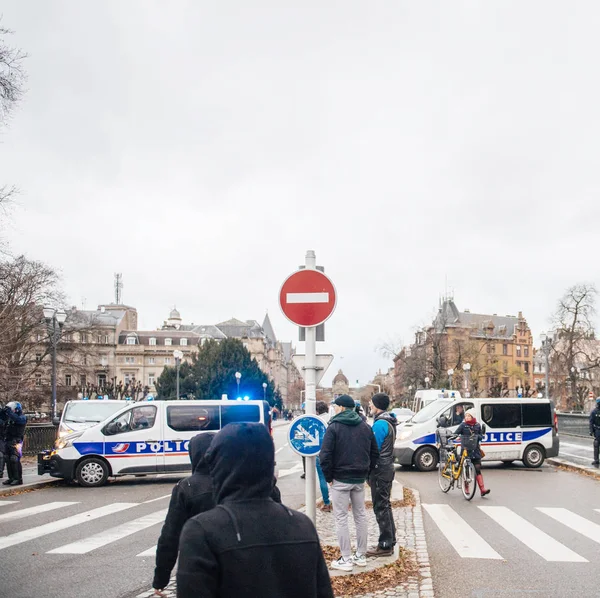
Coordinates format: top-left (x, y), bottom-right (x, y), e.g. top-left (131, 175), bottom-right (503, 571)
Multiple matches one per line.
top-left (0, 495), bottom-right (170, 558)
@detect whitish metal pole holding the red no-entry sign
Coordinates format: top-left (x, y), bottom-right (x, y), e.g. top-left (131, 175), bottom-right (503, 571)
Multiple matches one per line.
top-left (304, 250), bottom-right (317, 525)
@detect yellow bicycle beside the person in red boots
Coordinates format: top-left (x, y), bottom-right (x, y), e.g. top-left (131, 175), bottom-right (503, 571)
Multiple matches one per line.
top-left (437, 428), bottom-right (477, 500)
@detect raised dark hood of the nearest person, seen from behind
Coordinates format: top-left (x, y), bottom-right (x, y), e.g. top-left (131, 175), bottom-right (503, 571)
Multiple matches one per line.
top-left (206, 423), bottom-right (275, 504)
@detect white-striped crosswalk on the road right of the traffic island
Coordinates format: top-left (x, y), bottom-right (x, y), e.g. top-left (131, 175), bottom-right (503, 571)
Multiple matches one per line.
top-left (423, 504), bottom-right (600, 563)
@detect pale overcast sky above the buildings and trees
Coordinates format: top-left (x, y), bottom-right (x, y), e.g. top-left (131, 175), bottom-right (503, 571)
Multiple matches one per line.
top-left (0, 0), bottom-right (600, 390)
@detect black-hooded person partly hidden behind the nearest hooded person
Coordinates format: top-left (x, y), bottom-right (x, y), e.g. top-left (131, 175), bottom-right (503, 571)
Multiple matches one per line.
top-left (152, 433), bottom-right (215, 590)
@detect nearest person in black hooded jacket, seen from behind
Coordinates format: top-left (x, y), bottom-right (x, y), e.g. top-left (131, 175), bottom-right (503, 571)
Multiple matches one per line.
top-left (177, 423), bottom-right (333, 598)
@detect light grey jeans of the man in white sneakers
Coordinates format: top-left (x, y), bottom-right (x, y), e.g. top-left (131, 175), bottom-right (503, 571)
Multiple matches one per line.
top-left (331, 480), bottom-right (369, 559)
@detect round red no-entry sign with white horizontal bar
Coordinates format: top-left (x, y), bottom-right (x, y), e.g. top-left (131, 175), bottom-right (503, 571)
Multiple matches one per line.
top-left (279, 269), bottom-right (337, 328)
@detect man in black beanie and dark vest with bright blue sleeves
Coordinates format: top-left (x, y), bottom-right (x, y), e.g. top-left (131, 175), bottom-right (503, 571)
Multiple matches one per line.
top-left (367, 392), bottom-right (398, 556)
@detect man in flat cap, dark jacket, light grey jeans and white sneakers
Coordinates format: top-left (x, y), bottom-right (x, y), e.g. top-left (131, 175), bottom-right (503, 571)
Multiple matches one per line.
top-left (319, 395), bottom-right (379, 571)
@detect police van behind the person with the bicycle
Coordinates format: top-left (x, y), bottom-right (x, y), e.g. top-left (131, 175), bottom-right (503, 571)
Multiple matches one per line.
top-left (394, 398), bottom-right (559, 471)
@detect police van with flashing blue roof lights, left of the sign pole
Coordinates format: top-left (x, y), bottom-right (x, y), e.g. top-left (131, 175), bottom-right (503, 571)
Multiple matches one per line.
top-left (38, 400), bottom-right (271, 487)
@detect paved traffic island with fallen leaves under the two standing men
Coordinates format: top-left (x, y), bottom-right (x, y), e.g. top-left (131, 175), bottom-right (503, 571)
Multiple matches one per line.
top-left (134, 484), bottom-right (434, 598)
